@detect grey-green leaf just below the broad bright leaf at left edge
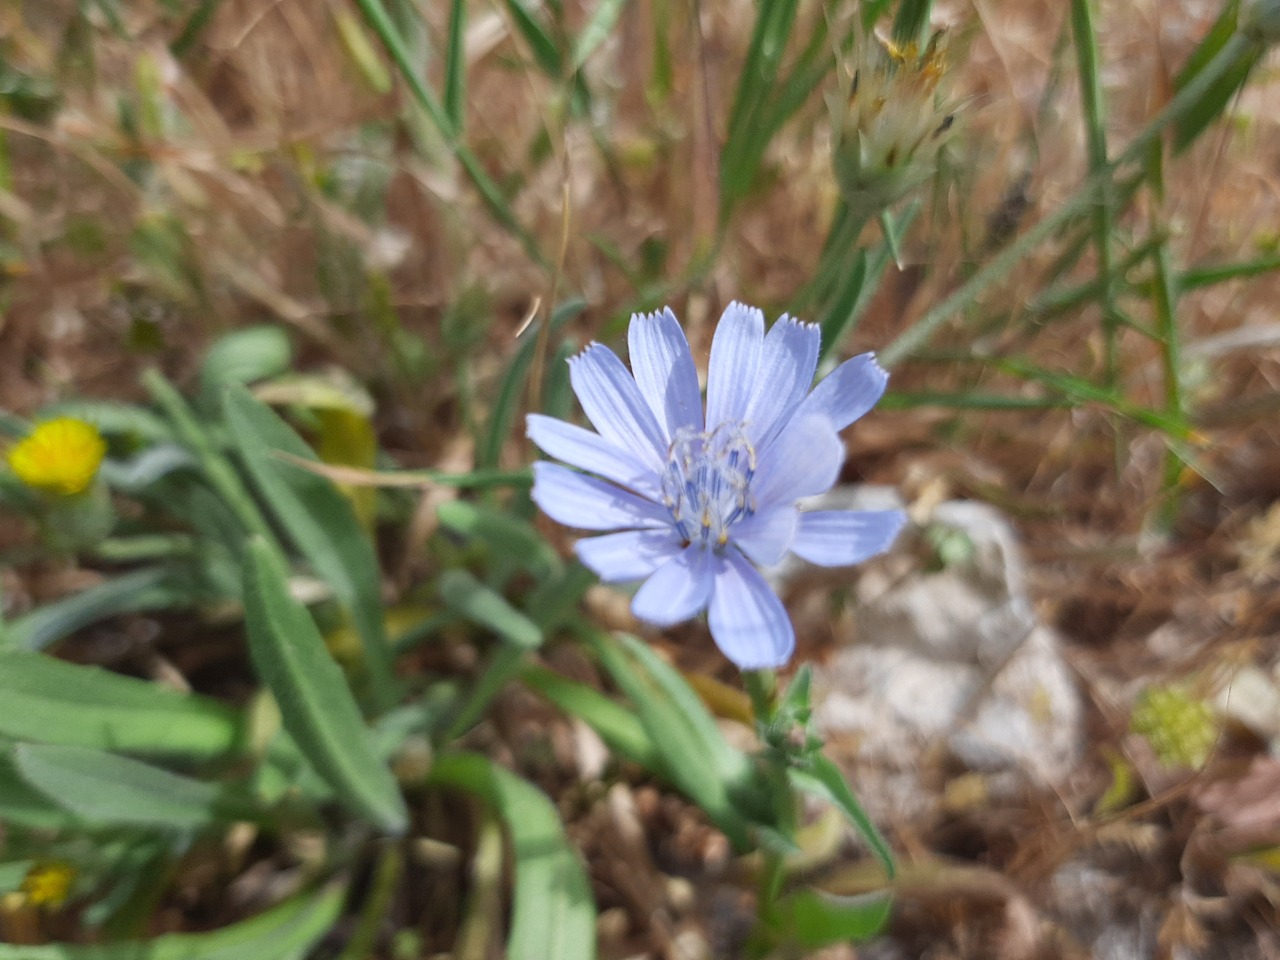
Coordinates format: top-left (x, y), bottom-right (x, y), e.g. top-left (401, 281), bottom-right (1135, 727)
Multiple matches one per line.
top-left (13, 744), bottom-right (261, 829)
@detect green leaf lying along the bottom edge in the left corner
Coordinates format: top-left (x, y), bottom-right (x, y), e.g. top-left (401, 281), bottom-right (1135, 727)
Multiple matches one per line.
top-left (0, 884), bottom-right (346, 960)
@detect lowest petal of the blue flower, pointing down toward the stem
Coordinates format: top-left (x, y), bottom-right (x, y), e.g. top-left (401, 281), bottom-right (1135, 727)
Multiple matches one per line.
top-left (708, 550), bottom-right (796, 669)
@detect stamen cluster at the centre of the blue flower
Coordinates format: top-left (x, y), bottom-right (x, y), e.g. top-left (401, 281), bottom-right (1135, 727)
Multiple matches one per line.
top-left (662, 424), bottom-right (755, 547)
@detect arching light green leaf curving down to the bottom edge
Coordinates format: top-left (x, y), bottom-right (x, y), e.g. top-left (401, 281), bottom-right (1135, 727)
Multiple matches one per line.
top-left (427, 753), bottom-right (595, 960)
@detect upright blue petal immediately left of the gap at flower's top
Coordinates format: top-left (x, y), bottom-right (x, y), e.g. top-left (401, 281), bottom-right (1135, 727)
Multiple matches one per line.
top-left (627, 307), bottom-right (703, 440)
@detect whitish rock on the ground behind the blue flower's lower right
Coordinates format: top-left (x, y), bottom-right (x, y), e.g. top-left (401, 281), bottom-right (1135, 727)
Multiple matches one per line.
top-left (803, 489), bottom-right (1082, 814)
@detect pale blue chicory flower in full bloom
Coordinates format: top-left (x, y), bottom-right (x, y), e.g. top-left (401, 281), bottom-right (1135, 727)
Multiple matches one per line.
top-left (527, 302), bottom-right (905, 669)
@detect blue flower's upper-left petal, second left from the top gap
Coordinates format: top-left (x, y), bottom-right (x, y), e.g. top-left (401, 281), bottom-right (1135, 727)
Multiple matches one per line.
top-left (568, 343), bottom-right (667, 468)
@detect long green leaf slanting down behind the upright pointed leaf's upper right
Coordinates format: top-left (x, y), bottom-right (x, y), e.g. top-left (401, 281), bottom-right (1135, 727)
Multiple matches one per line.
top-left (223, 385), bottom-right (397, 709)
